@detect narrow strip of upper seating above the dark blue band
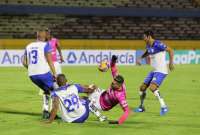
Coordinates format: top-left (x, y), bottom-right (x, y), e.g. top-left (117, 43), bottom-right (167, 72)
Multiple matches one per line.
top-left (0, 0), bottom-right (199, 9)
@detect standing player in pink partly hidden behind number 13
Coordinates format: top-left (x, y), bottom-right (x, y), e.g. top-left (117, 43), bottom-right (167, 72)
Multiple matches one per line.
top-left (46, 29), bottom-right (64, 74)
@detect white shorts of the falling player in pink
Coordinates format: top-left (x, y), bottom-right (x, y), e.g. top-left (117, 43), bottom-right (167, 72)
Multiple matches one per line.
top-left (88, 88), bottom-right (103, 111)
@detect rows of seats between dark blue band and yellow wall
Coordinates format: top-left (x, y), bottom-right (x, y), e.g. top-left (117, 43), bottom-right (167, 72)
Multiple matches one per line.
top-left (0, 14), bottom-right (200, 39)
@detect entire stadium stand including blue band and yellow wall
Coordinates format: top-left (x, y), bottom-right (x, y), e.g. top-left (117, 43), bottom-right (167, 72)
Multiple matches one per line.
top-left (0, 0), bottom-right (200, 49)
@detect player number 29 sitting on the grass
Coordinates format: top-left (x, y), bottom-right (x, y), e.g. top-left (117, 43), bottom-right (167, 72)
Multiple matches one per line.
top-left (47, 74), bottom-right (94, 123)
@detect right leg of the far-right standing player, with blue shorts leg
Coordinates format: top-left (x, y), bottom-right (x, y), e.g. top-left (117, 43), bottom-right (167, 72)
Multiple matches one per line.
top-left (149, 72), bottom-right (168, 115)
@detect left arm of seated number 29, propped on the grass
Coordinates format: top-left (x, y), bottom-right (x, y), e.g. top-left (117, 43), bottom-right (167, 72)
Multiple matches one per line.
top-left (47, 97), bottom-right (59, 123)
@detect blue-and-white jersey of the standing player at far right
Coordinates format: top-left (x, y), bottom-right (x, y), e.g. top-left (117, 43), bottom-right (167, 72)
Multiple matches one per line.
top-left (146, 40), bottom-right (168, 74)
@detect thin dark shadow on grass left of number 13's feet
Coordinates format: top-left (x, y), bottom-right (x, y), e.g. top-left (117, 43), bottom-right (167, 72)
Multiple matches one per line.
top-left (0, 109), bottom-right (41, 116)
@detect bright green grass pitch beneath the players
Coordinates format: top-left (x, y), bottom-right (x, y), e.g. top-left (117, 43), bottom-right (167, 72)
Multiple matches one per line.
top-left (0, 65), bottom-right (200, 135)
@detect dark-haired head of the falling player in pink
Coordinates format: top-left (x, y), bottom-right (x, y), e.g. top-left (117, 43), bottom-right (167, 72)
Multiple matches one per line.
top-left (111, 75), bottom-right (124, 90)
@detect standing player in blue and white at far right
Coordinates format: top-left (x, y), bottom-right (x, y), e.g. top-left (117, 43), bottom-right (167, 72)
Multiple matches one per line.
top-left (134, 31), bottom-right (174, 115)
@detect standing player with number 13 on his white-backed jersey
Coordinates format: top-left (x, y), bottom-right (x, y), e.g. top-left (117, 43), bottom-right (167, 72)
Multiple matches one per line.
top-left (23, 30), bottom-right (56, 119)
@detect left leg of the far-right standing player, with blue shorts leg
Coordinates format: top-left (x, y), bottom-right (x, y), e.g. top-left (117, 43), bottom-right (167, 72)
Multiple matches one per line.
top-left (134, 72), bottom-right (153, 112)
